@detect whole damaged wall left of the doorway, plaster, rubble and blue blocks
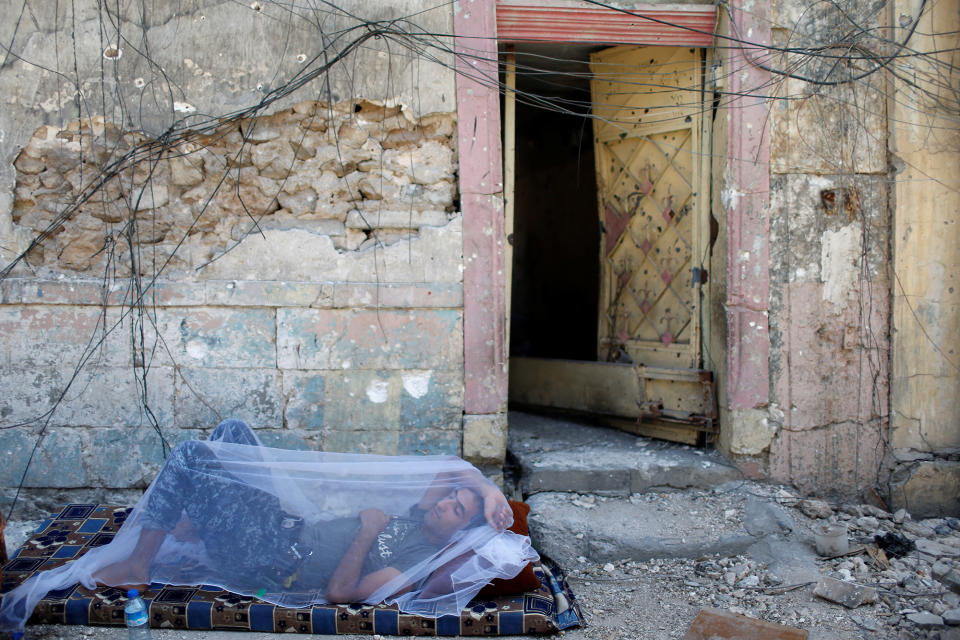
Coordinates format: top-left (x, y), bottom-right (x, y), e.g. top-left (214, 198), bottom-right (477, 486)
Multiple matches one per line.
top-left (0, 2), bottom-right (472, 510)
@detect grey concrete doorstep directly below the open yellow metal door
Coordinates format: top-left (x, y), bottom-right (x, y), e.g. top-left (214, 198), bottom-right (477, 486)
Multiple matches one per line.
top-left (507, 411), bottom-right (742, 496)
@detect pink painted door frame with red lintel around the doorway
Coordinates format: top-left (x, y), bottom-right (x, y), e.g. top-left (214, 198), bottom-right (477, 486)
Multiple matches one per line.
top-left (454, 0), bottom-right (770, 415)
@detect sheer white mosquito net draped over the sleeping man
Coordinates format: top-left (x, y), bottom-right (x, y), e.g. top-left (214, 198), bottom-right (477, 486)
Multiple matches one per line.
top-left (0, 421), bottom-right (537, 631)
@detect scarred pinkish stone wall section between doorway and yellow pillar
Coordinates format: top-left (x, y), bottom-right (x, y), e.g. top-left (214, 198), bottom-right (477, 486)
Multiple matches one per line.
top-left (714, 0), bottom-right (892, 498)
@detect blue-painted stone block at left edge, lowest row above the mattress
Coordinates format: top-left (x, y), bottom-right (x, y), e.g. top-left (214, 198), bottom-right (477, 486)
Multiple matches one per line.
top-left (0, 427), bottom-right (90, 488)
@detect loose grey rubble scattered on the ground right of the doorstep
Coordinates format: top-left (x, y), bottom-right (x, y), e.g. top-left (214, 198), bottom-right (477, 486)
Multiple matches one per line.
top-left (569, 483), bottom-right (960, 640)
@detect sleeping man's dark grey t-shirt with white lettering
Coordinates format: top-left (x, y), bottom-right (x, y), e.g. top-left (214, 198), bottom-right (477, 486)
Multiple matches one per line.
top-left (297, 508), bottom-right (442, 589)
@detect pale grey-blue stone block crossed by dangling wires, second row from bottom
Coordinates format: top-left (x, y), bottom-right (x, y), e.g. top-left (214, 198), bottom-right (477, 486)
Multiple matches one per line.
top-left (54, 365), bottom-right (174, 427)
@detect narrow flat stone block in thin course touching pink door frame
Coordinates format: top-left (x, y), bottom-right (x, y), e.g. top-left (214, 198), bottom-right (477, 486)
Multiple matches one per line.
top-left (332, 282), bottom-right (463, 309)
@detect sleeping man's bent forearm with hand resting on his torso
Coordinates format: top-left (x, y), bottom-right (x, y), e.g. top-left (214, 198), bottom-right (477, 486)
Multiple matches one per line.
top-left (326, 509), bottom-right (402, 603)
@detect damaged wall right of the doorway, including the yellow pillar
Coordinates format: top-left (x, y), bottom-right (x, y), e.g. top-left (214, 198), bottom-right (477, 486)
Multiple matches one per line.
top-left (711, 0), bottom-right (960, 515)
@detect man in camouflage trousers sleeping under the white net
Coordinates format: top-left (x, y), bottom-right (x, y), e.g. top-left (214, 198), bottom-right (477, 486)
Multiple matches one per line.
top-left (94, 420), bottom-right (513, 602)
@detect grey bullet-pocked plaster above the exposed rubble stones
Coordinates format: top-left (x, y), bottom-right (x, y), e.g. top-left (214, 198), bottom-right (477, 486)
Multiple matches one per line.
top-left (0, 0), bottom-right (456, 258)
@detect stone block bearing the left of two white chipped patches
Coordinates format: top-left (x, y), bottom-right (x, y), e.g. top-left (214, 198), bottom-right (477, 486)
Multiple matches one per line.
top-left (323, 370), bottom-right (401, 431)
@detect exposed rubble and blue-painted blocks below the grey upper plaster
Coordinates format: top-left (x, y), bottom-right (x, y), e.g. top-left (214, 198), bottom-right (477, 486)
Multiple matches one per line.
top-left (0, 101), bottom-right (464, 510)
